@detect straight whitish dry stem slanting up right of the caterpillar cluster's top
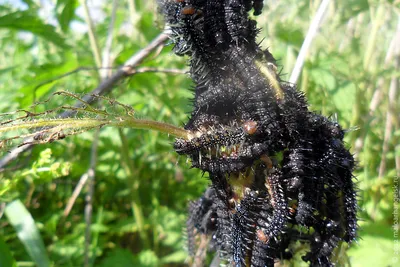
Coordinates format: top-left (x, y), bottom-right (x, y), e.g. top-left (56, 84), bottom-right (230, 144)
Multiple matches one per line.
top-left (289, 0), bottom-right (330, 83)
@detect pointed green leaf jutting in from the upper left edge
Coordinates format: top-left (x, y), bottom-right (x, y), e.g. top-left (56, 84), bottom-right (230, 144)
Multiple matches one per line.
top-left (0, 10), bottom-right (68, 48)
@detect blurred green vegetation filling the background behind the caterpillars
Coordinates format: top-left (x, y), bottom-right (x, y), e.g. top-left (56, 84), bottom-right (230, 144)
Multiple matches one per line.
top-left (0, 0), bottom-right (400, 267)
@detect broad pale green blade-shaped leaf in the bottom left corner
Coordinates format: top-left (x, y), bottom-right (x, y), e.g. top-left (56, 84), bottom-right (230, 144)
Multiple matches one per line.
top-left (5, 199), bottom-right (50, 267)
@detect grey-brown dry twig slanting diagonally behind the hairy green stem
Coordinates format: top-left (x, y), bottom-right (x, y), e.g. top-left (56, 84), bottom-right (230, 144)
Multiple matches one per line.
top-left (0, 33), bottom-right (168, 171)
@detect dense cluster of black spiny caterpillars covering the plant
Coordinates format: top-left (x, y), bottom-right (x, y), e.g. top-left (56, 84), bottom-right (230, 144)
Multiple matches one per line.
top-left (159, 0), bottom-right (357, 266)
